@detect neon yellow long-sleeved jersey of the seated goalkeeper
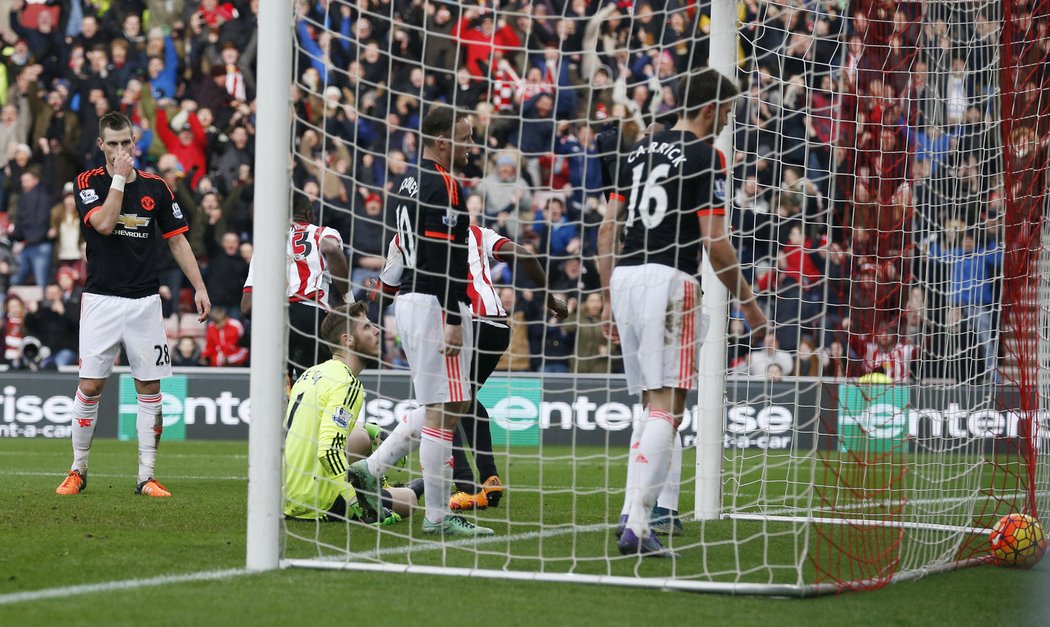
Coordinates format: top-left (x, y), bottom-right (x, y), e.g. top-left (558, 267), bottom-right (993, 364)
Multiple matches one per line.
top-left (285, 359), bottom-right (364, 519)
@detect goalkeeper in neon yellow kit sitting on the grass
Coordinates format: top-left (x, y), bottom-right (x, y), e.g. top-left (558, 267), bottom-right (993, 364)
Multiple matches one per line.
top-left (285, 302), bottom-right (422, 525)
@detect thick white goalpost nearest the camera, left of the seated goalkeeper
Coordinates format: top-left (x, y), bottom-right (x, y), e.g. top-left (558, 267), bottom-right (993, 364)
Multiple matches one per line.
top-left (246, 1), bottom-right (293, 570)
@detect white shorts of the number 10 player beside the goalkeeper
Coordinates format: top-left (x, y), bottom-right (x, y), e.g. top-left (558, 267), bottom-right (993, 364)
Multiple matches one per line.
top-left (394, 292), bottom-right (474, 405)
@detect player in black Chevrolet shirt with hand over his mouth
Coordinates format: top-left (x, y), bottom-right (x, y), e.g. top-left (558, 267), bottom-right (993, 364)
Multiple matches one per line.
top-left (56, 111), bottom-right (211, 497)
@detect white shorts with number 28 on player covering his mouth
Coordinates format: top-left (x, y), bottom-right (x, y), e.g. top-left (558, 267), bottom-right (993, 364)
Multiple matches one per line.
top-left (80, 293), bottom-right (171, 381)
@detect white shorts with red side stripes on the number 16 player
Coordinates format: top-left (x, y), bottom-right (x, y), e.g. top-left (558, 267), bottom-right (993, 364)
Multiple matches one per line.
top-left (609, 264), bottom-right (708, 394)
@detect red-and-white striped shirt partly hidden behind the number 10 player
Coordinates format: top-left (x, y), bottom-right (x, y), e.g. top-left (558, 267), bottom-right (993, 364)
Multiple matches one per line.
top-left (379, 226), bottom-right (510, 317)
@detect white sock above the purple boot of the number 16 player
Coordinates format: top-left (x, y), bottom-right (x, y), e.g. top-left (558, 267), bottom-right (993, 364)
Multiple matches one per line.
top-left (627, 410), bottom-right (675, 538)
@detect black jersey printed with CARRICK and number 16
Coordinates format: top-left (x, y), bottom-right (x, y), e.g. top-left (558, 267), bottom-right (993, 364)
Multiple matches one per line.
top-left (610, 130), bottom-right (726, 276)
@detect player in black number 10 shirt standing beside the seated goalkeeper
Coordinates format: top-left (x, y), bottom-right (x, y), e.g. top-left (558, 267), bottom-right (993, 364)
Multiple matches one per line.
top-left (348, 106), bottom-right (494, 536)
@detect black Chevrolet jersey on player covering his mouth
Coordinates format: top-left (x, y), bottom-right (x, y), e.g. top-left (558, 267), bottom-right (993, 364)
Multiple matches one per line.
top-left (75, 168), bottom-right (189, 298)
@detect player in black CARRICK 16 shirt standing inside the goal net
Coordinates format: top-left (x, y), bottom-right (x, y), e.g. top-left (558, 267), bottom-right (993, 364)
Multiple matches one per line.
top-left (599, 68), bottom-right (767, 557)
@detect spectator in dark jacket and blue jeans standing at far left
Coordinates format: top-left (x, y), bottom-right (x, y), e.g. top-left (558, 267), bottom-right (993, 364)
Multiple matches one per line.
top-left (14, 169), bottom-right (57, 289)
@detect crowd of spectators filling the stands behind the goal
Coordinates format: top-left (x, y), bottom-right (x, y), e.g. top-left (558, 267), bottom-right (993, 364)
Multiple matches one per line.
top-left (0, 0), bottom-right (1004, 380)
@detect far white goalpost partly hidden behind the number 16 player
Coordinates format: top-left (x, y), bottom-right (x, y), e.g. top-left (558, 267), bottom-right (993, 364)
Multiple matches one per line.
top-left (693, 0), bottom-right (737, 520)
